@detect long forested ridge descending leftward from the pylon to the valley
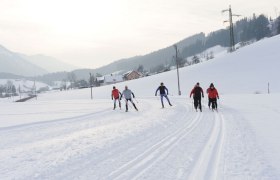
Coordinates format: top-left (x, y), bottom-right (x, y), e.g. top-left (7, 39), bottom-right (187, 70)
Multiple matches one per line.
top-left (70, 15), bottom-right (280, 78)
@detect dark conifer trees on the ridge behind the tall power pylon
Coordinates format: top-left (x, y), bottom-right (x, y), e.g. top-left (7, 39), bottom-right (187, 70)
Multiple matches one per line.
top-left (182, 14), bottom-right (280, 58)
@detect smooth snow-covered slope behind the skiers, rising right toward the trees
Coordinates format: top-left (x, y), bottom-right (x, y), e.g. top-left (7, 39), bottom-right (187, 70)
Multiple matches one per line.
top-left (33, 35), bottom-right (280, 99)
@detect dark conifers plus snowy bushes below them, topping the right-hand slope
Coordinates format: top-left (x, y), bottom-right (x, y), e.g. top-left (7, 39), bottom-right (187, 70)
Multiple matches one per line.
top-left (150, 14), bottom-right (280, 72)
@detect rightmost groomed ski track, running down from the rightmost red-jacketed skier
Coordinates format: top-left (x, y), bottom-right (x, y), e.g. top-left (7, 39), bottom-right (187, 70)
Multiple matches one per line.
top-left (188, 112), bottom-right (225, 180)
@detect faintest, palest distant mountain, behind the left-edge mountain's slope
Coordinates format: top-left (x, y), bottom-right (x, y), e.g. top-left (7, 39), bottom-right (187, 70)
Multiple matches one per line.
top-left (20, 54), bottom-right (77, 73)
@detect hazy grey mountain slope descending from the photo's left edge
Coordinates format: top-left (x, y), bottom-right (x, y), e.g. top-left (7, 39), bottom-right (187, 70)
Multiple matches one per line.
top-left (0, 45), bottom-right (48, 76)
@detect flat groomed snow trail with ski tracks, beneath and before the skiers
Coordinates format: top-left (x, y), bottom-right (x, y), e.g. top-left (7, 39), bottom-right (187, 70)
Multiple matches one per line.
top-left (0, 98), bottom-right (280, 180)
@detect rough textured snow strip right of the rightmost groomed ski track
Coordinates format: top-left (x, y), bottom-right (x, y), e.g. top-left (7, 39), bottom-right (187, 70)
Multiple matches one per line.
top-left (221, 106), bottom-right (280, 180)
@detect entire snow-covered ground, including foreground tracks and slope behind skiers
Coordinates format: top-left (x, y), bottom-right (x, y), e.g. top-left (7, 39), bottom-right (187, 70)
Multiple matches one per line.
top-left (0, 36), bottom-right (280, 180)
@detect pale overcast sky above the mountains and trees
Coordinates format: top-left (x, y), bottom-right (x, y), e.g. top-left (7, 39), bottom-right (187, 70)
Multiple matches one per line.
top-left (0, 0), bottom-right (280, 68)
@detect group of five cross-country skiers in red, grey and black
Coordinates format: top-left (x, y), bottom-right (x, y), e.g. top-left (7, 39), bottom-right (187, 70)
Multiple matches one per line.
top-left (111, 82), bottom-right (219, 112)
